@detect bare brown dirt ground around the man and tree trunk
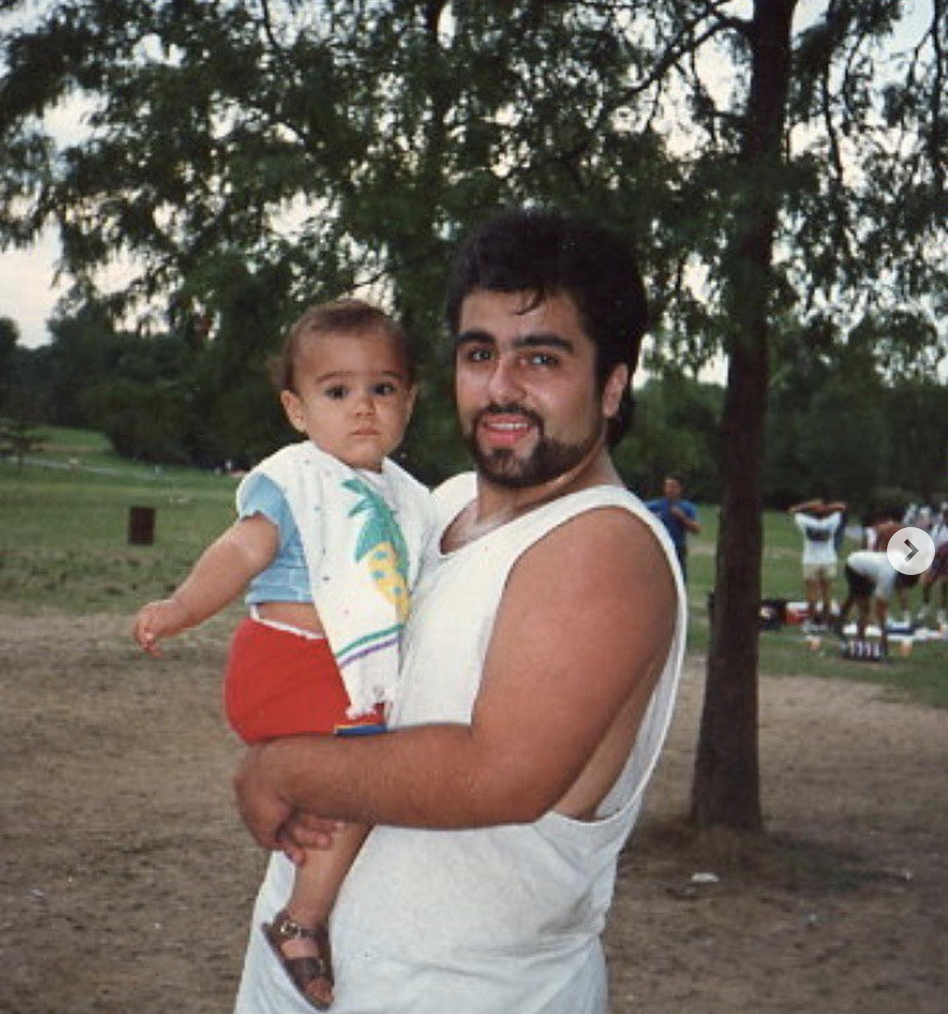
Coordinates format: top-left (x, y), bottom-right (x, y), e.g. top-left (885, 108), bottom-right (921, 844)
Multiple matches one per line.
top-left (0, 615), bottom-right (948, 1014)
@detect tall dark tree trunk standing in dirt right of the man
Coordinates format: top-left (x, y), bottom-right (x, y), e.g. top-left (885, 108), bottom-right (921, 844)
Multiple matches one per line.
top-left (691, 0), bottom-right (797, 830)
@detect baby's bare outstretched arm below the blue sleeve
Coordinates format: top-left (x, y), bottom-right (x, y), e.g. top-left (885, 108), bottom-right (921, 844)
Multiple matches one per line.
top-left (133, 514), bottom-right (279, 655)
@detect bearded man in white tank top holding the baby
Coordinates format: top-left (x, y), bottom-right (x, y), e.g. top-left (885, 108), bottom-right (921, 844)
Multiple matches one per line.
top-left (235, 212), bottom-right (685, 1014)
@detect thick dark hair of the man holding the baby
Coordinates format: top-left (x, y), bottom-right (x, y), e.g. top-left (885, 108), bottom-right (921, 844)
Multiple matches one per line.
top-left (445, 209), bottom-right (648, 446)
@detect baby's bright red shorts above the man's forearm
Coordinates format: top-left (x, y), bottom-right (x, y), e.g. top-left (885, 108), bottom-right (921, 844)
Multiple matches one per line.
top-left (224, 617), bottom-right (384, 743)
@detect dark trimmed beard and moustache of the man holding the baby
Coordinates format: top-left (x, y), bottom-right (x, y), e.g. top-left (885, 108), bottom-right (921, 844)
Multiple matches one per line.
top-left (464, 405), bottom-right (602, 490)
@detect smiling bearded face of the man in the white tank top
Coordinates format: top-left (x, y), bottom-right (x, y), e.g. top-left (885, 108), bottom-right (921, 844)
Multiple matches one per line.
top-left (455, 289), bottom-right (628, 489)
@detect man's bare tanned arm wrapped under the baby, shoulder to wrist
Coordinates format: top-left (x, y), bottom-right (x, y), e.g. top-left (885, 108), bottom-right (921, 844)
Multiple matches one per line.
top-left (235, 509), bottom-right (676, 848)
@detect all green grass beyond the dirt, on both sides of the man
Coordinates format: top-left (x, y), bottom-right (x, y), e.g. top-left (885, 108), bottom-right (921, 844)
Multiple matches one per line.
top-left (0, 427), bottom-right (948, 707)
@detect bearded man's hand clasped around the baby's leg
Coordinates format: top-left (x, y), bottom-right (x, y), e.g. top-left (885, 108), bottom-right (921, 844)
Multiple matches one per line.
top-left (234, 740), bottom-right (340, 866)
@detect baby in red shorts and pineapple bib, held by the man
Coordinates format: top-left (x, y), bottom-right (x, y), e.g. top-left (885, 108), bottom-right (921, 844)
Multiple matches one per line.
top-left (134, 300), bottom-right (431, 1010)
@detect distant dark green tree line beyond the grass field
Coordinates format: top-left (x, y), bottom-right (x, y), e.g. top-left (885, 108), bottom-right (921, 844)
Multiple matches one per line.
top-left (0, 304), bottom-right (948, 510)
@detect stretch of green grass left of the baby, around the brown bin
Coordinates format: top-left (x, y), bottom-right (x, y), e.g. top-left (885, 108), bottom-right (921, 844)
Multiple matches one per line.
top-left (0, 428), bottom-right (235, 613)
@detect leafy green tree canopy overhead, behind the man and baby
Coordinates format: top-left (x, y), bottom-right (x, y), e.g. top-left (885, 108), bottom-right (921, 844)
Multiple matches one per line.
top-left (0, 0), bottom-right (948, 474)
